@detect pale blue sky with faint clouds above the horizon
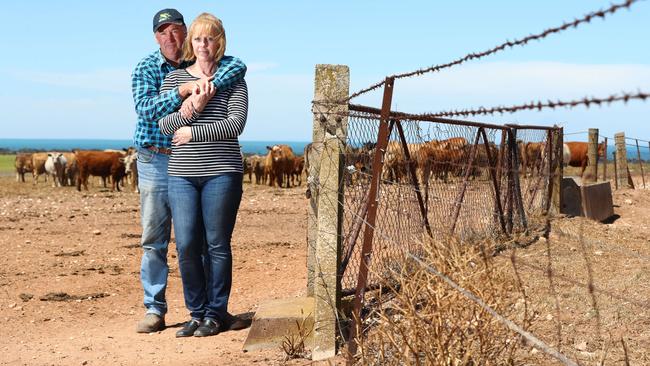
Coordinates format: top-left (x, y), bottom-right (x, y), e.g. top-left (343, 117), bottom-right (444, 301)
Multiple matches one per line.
top-left (0, 0), bottom-right (650, 141)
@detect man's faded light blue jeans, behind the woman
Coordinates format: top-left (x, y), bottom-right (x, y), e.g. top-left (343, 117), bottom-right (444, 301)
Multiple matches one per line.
top-left (138, 149), bottom-right (171, 316)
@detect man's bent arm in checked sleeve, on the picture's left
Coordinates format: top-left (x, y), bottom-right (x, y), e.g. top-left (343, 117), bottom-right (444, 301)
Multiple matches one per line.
top-left (131, 65), bottom-right (182, 121)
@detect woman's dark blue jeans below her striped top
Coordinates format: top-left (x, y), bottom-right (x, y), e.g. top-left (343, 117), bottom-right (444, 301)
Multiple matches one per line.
top-left (169, 173), bottom-right (242, 321)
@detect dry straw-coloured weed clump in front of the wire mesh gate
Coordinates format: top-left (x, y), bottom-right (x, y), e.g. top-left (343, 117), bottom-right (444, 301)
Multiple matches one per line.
top-left (357, 239), bottom-right (521, 365)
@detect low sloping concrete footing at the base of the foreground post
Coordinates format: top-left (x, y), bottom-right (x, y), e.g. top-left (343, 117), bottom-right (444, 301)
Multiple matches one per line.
top-left (244, 297), bottom-right (314, 351)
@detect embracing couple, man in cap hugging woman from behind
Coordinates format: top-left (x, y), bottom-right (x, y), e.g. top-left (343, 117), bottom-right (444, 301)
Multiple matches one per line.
top-left (132, 9), bottom-right (248, 337)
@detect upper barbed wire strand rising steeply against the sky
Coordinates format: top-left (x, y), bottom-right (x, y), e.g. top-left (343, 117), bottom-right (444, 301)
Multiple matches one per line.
top-left (345, 0), bottom-right (640, 101)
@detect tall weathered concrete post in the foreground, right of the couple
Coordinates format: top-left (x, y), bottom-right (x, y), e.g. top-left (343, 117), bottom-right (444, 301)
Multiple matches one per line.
top-left (307, 65), bottom-right (350, 360)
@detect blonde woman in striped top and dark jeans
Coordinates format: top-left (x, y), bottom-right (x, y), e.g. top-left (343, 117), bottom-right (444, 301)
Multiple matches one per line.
top-left (159, 13), bottom-right (248, 337)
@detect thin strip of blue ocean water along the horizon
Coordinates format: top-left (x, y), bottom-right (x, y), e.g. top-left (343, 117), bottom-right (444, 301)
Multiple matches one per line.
top-left (0, 139), bottom-right (309, 155)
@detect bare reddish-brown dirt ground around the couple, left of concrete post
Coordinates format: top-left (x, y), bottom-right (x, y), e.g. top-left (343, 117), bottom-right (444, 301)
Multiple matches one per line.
top-left (0, 176), bottom-right (314, 365)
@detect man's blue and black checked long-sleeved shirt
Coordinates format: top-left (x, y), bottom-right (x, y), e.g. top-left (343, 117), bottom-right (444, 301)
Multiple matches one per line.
top-left (131, 50), bottom-right (246, 148)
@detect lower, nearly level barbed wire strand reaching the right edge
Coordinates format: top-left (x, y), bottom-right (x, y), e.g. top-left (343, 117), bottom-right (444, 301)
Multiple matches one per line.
top-left (421, 92), bottom-right (650, 118)
